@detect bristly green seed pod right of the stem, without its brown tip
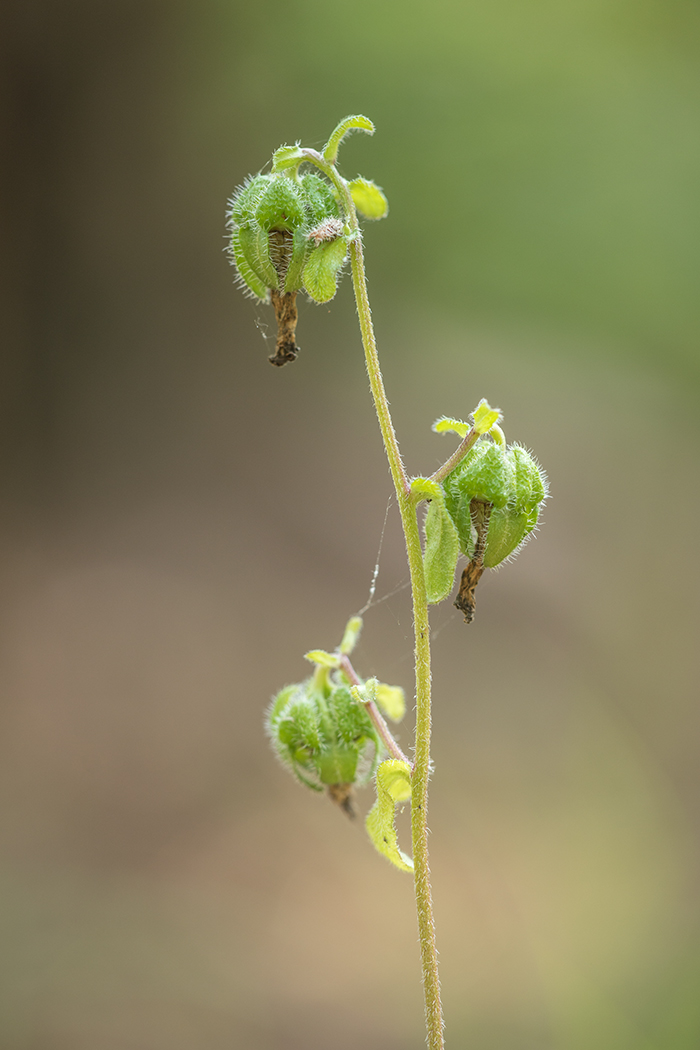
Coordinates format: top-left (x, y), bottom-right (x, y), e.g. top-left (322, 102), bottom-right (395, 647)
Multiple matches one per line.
top-left (442, 437), bottom-right (547, 568)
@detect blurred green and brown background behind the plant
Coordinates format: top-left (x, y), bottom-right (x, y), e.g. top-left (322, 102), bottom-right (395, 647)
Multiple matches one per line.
top-left (0, 0), bottom-right (700, 1050)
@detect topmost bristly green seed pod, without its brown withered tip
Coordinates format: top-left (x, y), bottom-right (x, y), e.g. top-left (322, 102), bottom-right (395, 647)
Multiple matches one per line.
top-left (227, 172), bottom-right (348, 302)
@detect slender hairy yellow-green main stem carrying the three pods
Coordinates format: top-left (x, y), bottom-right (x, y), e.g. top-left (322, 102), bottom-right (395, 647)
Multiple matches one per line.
top-left (344, 234), bottom-right (444, 1050)
